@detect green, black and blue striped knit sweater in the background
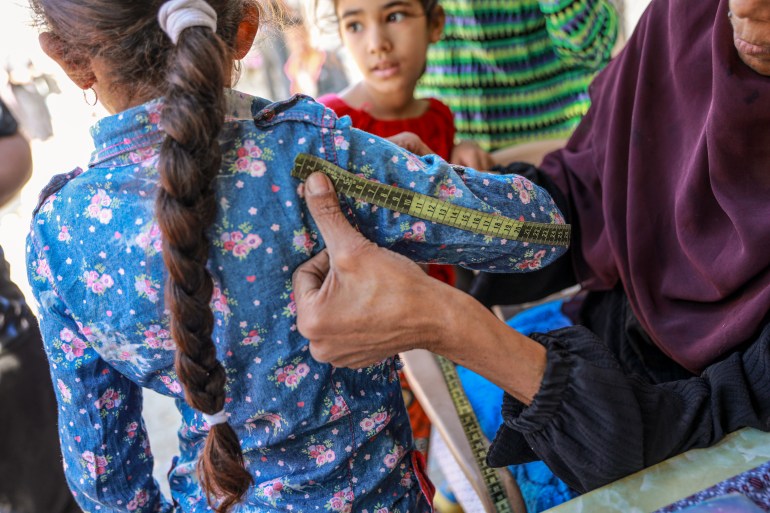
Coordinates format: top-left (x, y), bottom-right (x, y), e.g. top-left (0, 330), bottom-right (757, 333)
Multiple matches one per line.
top-left (418, 0), bottom-right (618, 150)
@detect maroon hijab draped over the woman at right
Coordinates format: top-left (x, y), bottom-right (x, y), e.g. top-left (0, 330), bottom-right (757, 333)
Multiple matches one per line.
top-left (543, 0), bottom-right (770, 372)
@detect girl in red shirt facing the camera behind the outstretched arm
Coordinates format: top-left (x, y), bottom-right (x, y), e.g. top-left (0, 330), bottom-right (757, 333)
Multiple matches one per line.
top-left (318, 0), bottom-right (493, 454)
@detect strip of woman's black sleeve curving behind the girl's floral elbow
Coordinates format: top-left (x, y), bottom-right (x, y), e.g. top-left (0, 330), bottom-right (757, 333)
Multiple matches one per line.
top-left (468, 162), bottom-right (577, 307)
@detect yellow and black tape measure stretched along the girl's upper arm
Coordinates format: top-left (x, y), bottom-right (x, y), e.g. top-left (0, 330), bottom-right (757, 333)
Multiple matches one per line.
top-left (291, 153), bottom-right (570, 246)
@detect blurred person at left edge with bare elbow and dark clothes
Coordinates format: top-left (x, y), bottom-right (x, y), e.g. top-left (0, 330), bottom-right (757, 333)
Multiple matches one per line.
top-left (0, 101), bottom-right (80, 513)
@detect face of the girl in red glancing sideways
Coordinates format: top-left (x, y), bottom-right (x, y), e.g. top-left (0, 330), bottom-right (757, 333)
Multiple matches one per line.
top-left (337, 0), bottom-right (444, 100)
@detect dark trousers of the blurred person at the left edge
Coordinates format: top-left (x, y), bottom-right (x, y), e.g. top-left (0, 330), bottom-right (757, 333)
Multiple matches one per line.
top-left (0, 321), bottom-right (80, 513)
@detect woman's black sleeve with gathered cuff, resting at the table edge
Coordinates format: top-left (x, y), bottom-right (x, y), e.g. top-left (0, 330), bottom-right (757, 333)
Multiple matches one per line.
top-left (488, 325), bottom-right (770, 492)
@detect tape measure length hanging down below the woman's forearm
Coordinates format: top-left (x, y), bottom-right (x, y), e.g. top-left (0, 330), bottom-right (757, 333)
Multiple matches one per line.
top-left (436, 355), bottom-right (513, 513)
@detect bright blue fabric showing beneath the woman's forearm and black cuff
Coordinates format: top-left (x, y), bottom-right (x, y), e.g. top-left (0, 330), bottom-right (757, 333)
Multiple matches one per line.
top-left (457, 300), bottom-right (577, 513)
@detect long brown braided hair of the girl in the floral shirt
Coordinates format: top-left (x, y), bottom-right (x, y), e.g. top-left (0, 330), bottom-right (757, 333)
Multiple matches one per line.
top-left (30, 0), bottom-right (257, 513)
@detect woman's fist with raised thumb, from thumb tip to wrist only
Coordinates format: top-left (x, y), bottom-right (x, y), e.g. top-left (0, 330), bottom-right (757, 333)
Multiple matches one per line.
top-left (294, 173), bottom-right (453, 368)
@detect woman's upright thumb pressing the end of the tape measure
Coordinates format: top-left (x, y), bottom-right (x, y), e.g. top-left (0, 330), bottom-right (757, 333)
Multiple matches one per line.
top-left (305, 173), bottom-right (363, 255)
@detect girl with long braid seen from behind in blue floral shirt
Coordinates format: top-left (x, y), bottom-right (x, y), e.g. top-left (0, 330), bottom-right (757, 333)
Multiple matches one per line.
top-left (27, 0), bottom-right (563, 513)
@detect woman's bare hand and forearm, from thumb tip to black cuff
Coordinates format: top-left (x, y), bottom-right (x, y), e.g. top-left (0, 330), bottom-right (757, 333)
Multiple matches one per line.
top-left (294, 173), bottom-right (545, 404)
